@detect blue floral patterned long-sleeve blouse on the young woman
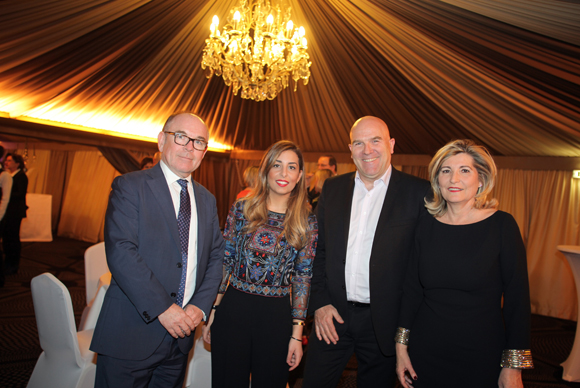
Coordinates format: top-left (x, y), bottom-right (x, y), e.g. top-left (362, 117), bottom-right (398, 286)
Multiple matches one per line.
top-left (219, 201), bottom-right (318, 320)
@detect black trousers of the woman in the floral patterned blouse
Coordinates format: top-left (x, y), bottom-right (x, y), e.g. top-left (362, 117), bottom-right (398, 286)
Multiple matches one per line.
top-left (211, 286), bottom-right (292, 388)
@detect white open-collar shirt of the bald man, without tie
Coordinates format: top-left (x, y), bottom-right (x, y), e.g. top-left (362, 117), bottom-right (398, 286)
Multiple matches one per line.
top-left (344, 165), bottom-right (392, 303)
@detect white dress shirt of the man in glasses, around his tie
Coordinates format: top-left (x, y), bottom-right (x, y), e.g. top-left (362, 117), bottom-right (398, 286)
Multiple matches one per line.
top-left (159, 160), bottom-right (197, 307)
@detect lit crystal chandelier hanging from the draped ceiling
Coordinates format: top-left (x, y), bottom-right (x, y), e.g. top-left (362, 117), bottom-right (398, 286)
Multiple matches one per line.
top-left (201, 0), bottom-right (311, 101)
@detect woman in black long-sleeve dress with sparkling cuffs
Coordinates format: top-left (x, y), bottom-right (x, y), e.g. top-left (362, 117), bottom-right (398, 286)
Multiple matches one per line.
top-left (396, 140), bottom-right (533, 388)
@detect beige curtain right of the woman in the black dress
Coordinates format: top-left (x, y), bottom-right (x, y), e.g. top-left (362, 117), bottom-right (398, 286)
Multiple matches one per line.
top-left (495, 170), bottom-right (580, 320)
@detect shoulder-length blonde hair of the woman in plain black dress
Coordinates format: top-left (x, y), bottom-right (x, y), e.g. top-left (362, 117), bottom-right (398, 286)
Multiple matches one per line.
top-left (425, 139), bottom-right (498, 217)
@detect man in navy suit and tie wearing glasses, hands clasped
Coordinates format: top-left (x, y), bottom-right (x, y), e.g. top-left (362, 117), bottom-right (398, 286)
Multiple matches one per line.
top-left (91, 113), bottom-right (224, 388)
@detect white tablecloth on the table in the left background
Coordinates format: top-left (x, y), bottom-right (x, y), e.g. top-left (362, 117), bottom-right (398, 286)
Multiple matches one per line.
top-left (20, 193), bottom-right (52, 241)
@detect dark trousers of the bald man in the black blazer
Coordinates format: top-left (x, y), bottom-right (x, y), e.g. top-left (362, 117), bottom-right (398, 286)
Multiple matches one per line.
top-left (302, 303), bottom-right (396, 388)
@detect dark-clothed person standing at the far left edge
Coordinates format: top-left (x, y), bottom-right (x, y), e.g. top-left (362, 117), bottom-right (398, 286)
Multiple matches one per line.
top-left (2, 153), bottom-right (28, 275)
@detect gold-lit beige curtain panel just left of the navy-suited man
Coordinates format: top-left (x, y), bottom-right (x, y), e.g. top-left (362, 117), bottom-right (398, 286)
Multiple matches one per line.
top-left (58, 151), bottom-right (119, 243)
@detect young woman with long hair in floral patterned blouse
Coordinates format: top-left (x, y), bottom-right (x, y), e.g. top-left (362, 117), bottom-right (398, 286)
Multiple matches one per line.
top-left (203, 140), bottom-right (318, 388)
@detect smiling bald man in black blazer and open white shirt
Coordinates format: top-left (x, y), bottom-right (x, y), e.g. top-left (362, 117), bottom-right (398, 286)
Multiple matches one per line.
top-left (303, 116), bottom-right (429, 388)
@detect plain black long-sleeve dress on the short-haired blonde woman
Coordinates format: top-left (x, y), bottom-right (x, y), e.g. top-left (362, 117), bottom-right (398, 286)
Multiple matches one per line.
top-left (400, 211), bottom-right (530, 388)
